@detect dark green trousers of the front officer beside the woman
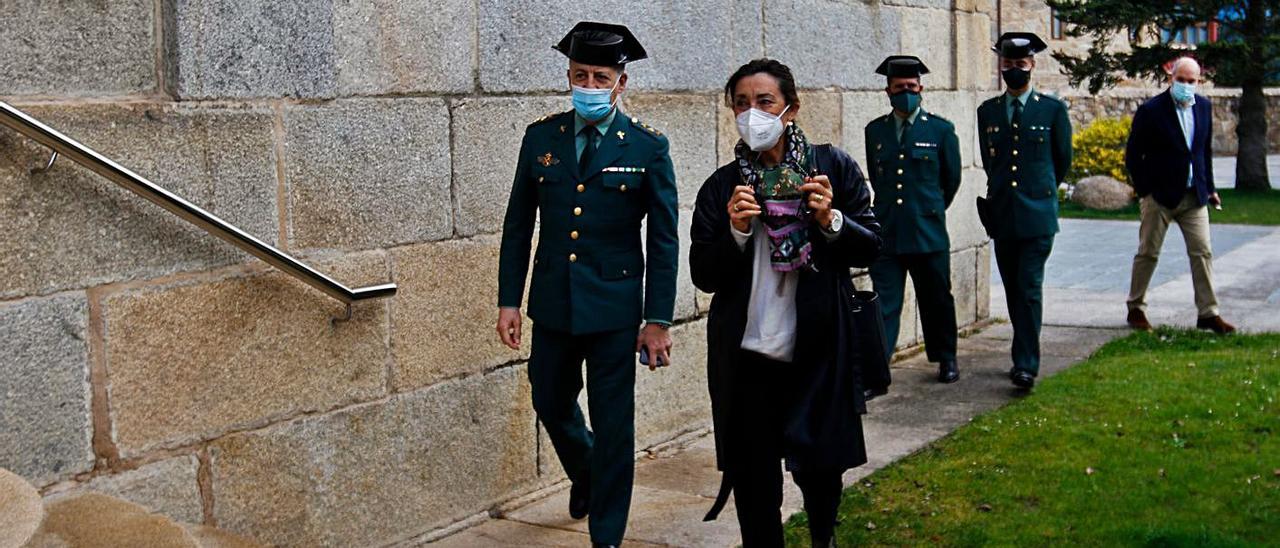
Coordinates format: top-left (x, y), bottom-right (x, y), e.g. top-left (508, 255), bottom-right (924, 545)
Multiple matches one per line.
top-left (529, 323), bottom-right (639, 544)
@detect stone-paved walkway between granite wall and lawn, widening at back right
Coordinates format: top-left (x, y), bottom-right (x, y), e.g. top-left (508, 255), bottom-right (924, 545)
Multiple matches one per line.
top-left (433, 216), bottom-right (1280, 547)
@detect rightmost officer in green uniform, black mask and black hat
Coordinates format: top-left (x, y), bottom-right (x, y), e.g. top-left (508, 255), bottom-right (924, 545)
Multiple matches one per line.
top-left (978, 32), bottom-right (1071, 388)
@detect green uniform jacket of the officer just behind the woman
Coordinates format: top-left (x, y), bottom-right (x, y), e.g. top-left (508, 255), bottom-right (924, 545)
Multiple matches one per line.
top-left (864, 110), bottom-right (960, 255)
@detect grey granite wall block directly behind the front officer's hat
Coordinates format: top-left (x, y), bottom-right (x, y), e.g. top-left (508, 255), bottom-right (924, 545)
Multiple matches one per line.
top-left (479, 0), bottom-right (749, 92)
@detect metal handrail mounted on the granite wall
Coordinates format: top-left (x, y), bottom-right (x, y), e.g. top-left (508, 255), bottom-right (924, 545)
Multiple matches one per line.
top-left (0, 101), bottom-right (396, 306)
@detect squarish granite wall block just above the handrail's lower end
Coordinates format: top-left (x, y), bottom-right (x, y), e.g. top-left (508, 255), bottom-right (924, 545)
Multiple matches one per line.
top-left (284, 99), bottom-right (453, 248)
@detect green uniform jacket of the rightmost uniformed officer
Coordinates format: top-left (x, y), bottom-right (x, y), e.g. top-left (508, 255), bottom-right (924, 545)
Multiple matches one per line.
top-left (978, 90), bottom-right (1071, 239)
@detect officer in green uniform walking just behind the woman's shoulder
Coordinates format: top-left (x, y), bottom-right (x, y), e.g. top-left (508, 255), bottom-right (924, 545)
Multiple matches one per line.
top-left (864, 55), bottom-right (960, 383)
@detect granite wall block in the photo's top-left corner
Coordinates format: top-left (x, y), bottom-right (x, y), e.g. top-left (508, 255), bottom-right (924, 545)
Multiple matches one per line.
top-left (0, 0), bottom-right (157, 97)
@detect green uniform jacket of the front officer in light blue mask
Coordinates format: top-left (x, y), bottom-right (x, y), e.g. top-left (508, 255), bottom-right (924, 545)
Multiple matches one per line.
top-left (498, 110), bottom-right (680, 334)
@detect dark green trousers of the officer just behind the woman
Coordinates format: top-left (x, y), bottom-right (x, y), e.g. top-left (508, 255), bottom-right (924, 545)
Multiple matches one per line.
top-left (870, 251), bottom-right (956, 362)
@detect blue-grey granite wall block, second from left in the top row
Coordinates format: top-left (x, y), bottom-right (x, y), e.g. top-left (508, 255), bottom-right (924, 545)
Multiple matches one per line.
top-left (173, 0), bottom-right (338, 99)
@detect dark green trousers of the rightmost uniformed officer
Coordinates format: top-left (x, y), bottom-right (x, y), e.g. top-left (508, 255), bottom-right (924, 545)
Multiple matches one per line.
top-left (996, 234), bottom-right (1053, 375)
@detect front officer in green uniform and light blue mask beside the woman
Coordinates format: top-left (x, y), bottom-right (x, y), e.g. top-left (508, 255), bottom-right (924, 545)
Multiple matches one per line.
top-left (498, 22), bottom-right (680, 545)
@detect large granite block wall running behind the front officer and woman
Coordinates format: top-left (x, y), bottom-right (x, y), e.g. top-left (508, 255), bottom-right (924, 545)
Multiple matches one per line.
top-left (0, 0), bottom-right (993, 545)
